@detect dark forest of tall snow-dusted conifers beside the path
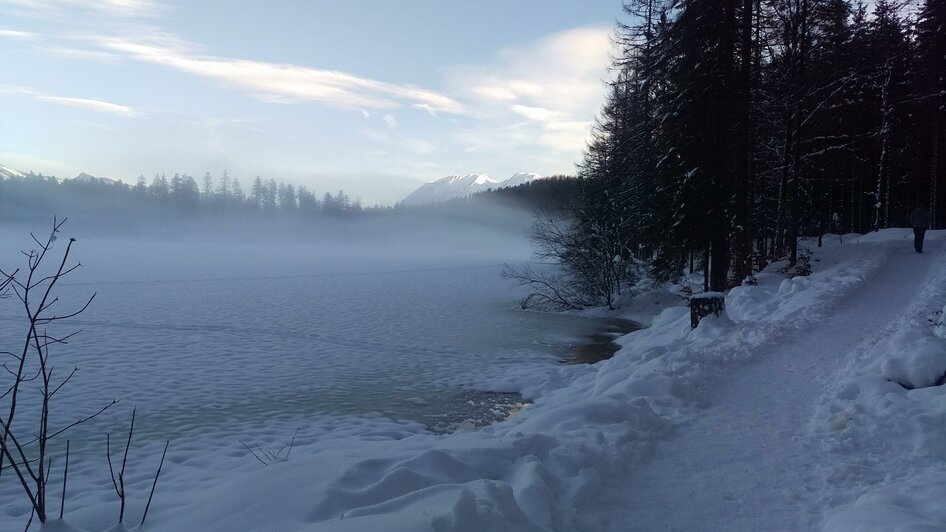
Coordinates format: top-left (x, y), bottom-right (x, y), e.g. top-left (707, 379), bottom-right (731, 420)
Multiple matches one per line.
top-left (537, 0), bottom-right (946, 304)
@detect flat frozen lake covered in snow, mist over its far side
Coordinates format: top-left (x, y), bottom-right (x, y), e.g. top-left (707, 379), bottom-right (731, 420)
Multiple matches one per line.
top-left (0, 220), bottom-right (624, 454)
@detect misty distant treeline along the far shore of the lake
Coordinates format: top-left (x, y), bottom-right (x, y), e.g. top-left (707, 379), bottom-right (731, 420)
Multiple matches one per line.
top-left (0, 172), bottom-right (577, 229)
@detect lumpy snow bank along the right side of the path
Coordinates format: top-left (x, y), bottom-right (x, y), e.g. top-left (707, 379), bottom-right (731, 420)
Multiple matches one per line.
top-left (811, 230), bottom-right (946, 532)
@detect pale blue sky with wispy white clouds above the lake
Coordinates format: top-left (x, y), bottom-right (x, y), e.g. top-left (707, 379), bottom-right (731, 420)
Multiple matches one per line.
top-left (0, 0), bottom-right (622, 204)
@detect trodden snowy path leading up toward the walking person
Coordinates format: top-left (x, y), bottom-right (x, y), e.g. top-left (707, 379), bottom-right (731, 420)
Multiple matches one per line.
top-left (581, 242), bottom-right (941, 532)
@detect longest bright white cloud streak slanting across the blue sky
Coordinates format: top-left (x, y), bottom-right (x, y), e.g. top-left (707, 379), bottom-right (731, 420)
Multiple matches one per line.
top-left (97, 35), bottom-right (465, 114)
